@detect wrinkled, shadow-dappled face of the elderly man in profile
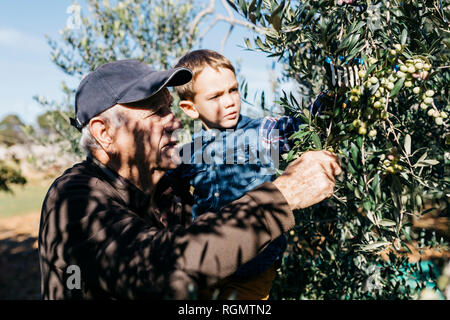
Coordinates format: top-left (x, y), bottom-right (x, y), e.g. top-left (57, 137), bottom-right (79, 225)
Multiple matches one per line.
top-left (114, 89), bottom-right (182, 174)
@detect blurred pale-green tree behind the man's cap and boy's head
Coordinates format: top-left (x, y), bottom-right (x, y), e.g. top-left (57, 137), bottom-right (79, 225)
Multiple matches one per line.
top-left (27, 0), bottom-right (258, 161)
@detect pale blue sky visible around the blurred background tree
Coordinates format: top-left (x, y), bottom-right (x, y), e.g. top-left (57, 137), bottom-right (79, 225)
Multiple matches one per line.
top-left (0, 0), bottom-right (288, 123)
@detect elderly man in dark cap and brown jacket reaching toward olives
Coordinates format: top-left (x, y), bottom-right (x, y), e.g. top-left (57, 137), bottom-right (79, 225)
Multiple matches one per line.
top-left (39, 60), bottom-right (341, 299)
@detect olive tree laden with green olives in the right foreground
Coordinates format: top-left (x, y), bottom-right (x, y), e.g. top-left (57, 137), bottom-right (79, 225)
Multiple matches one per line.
top-left (230, 0), bottom-right (450, 299)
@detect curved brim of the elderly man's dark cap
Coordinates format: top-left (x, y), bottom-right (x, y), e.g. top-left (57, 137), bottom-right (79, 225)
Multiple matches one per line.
top-left (117, 68), bottom-right (192, 104)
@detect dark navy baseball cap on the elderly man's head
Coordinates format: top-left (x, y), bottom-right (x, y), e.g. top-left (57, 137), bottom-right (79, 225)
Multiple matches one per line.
top-left (70, 60), bottom-right (192, 131)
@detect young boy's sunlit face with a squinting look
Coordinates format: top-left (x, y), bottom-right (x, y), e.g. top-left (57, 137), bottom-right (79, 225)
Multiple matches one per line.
top-left (193, 66), bottom-right (241, 129)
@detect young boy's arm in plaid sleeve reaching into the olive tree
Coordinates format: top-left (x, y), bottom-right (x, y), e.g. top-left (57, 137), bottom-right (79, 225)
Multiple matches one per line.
top-left (261, 91), bottom-right (327, 153)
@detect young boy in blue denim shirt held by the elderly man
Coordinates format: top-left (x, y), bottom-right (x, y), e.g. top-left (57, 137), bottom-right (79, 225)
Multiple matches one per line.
top-left (168, 50), bottom-right (324, 300)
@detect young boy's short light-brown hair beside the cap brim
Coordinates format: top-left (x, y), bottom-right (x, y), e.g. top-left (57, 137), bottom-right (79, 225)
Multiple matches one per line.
top-left (175, 49), bottom-right (236, 101)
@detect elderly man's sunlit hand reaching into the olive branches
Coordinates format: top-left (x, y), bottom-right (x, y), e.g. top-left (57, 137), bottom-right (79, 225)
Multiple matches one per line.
top-left (273, 151), bottom-right (342, 210)
